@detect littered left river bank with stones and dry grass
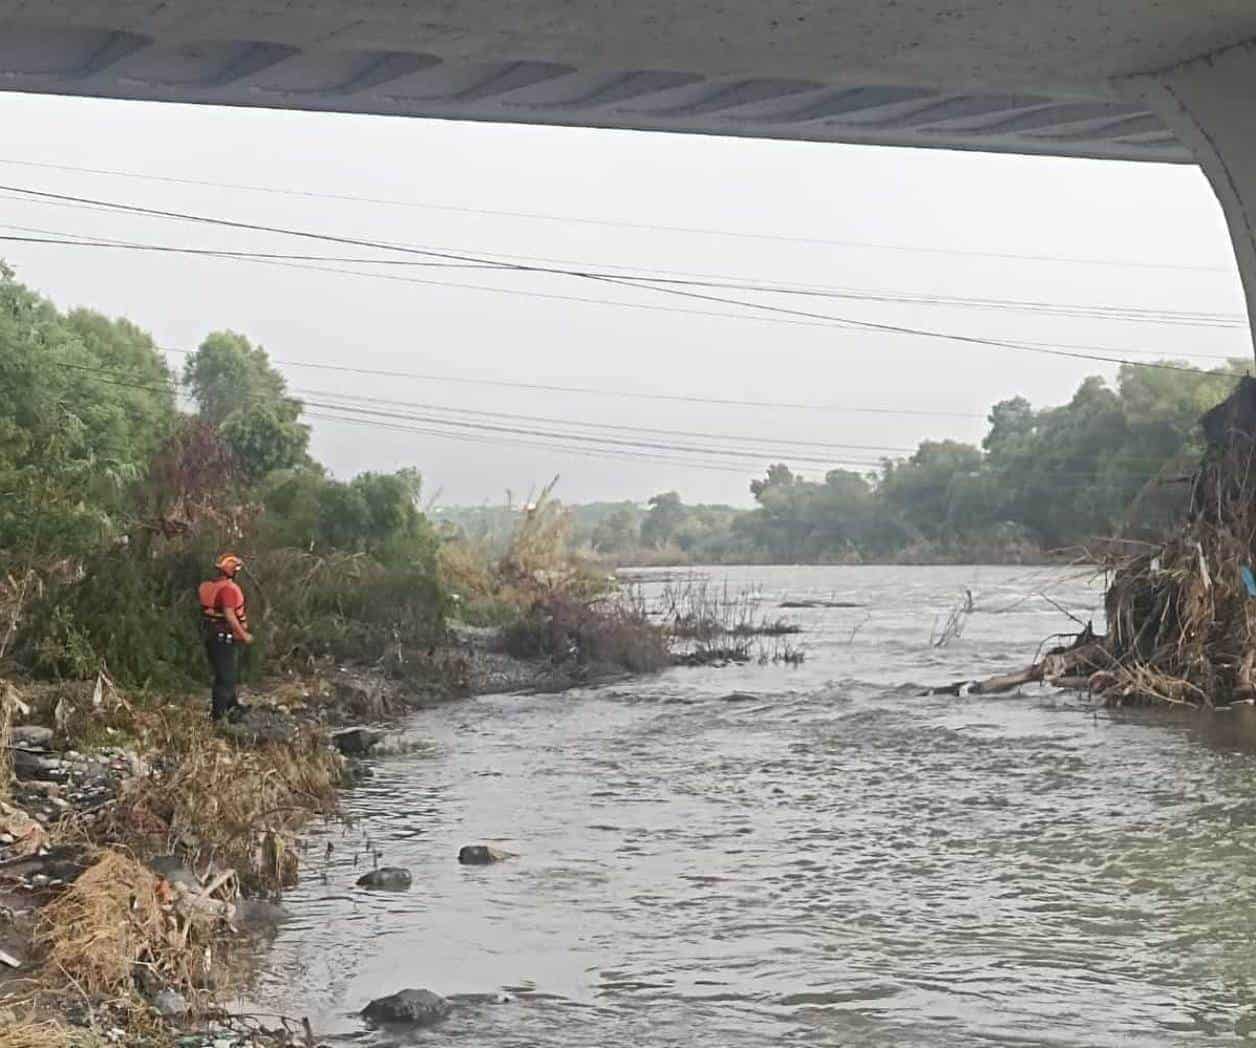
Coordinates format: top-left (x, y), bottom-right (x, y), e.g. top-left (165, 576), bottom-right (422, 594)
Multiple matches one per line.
top-left (0, 615), bottom-right (648, 1048)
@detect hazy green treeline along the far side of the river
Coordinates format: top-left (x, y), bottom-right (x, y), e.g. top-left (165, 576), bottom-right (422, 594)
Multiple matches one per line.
top-left (436, 361), bottom-right (1246, 564)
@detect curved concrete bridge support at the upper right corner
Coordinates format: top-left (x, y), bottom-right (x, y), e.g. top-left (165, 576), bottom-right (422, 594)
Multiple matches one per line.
top-left (1115, 40), bottom-right (1256, 351)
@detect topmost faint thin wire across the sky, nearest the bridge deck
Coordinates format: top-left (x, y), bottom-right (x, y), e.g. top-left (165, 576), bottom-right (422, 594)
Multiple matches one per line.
top-left (0, 157), bottom-right (1232, 273)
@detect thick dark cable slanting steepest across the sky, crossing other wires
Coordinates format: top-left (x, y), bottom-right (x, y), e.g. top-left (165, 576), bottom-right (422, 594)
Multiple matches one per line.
top-left (0, 185), bottom-right (1235, 372)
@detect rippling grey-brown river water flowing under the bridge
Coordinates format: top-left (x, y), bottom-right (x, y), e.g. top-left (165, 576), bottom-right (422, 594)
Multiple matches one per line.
top-left (247, 568), bottom-right (1256, 1048)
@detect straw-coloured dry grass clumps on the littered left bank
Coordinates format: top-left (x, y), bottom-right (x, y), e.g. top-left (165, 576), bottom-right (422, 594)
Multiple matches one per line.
top-left (0, 686), bottom-right (343, 1048)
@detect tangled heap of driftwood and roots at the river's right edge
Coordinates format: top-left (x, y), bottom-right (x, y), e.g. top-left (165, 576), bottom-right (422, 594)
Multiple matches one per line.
top-left (931, 377), bottom-right (1256, 707)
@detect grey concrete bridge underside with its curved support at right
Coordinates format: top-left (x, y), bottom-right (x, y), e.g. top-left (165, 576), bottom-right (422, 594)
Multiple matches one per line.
top-left (0, 0), bottom-right (1256, 339)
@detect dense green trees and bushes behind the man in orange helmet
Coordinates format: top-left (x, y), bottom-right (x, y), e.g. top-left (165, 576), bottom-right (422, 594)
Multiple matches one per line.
top-left (0, 270), bottom-right (446, 689)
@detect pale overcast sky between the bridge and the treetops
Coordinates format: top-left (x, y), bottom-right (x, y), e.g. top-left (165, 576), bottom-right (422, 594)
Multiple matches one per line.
top-left (0, 93), bottom-right (1251, 505)
